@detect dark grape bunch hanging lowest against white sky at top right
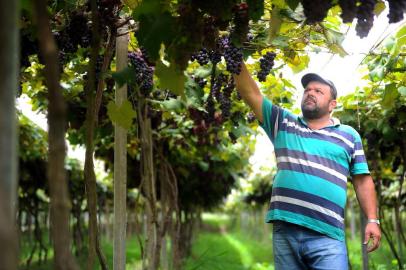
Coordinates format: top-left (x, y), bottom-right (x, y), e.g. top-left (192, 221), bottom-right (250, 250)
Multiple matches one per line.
top-left (355, 0), bottom-right (376, 38)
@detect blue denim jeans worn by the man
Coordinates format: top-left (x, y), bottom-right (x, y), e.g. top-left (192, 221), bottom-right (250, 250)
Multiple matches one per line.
top-left (272, 221), bottom-right (348, 270)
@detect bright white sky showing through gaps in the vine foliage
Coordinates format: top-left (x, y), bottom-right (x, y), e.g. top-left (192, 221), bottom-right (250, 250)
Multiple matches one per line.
top-left (17, 9), bottom-right (406, 173)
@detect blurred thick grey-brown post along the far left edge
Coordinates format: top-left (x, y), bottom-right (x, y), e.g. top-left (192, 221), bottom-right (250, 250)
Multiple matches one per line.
top-left (0, 1), bottom-right (20, 269)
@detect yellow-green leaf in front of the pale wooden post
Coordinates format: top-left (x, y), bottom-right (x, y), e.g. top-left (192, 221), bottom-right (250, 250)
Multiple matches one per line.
top-left (107, 100), bottom-right (137, 129)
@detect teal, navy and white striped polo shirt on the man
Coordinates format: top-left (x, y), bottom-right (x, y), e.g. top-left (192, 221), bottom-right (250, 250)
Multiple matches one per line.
top-left (261, 97), bottom-right (369, 241)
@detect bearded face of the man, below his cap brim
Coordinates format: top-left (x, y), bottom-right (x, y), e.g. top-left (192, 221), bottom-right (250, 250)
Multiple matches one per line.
top-left (302, 81), bottom-right (337, 119)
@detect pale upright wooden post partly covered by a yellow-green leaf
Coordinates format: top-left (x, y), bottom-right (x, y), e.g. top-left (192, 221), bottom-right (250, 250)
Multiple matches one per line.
top-left (113, 25), bottom-right (128, 270)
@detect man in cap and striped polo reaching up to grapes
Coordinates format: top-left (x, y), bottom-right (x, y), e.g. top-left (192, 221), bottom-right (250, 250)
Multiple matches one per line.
top-left (234, 64), bottom-right (381, 270)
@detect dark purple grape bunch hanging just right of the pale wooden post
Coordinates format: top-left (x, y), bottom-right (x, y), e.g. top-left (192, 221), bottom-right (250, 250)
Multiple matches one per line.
top-left (128, 52), bottom-right (154, 95)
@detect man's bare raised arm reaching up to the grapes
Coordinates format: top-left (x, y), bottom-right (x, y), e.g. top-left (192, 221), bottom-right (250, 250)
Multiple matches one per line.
top-left (234, 63), bottom-right (263, 122)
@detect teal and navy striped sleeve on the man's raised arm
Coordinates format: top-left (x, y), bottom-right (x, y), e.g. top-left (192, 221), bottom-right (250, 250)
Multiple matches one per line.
top-left (260, 97), bottom-right (283, 142)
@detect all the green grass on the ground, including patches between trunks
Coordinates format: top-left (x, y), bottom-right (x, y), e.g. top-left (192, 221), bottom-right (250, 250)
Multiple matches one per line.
top-left (20, 214), bottom-right (406, 270)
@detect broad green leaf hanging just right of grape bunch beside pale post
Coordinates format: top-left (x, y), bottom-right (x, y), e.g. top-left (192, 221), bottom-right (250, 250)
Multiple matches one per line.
top-left (155, 61), bottom-right (185, 96)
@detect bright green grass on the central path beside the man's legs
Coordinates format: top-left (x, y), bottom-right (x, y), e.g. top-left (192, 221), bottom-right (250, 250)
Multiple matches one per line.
top-left (185, 214), bottom-right (273, 270)
